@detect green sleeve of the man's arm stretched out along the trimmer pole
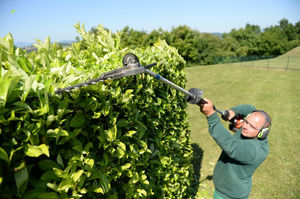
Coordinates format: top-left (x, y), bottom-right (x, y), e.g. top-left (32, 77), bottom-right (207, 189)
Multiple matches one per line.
top-left (207, 113), bottom-right (258, 164)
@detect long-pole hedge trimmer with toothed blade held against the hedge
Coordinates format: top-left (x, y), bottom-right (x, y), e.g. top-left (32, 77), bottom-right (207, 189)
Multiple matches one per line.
top-left (55, 53), bottom-right (242, 131)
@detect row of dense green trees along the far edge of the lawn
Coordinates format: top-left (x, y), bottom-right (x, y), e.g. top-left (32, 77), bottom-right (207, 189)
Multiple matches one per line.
top-left (85, 19), bottom-right (300, 64)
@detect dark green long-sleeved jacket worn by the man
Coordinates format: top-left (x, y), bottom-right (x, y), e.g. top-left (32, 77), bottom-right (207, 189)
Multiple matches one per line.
top-left (207, 105), bottom-right (269, 198)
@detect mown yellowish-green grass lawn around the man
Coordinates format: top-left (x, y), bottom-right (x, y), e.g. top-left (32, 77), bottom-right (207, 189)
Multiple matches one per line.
top-left (186, 64), bottom-right (300, 199)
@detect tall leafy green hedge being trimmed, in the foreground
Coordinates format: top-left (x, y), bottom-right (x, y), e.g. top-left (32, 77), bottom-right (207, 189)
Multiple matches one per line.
top-left (0, 24), bottom-right (194, 199)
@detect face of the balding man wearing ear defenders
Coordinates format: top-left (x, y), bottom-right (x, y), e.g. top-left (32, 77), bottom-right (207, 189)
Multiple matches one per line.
top-left (242, 112), bottom-right (265, 138)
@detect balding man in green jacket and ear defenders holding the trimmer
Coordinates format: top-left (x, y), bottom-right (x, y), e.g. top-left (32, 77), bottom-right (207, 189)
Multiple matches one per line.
top-left (200, 99), bottom-right (271, 199)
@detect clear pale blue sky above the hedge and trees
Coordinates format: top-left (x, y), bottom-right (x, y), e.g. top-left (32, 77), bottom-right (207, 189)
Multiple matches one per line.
top-left (0, 0), bottom-right (300, 42)
